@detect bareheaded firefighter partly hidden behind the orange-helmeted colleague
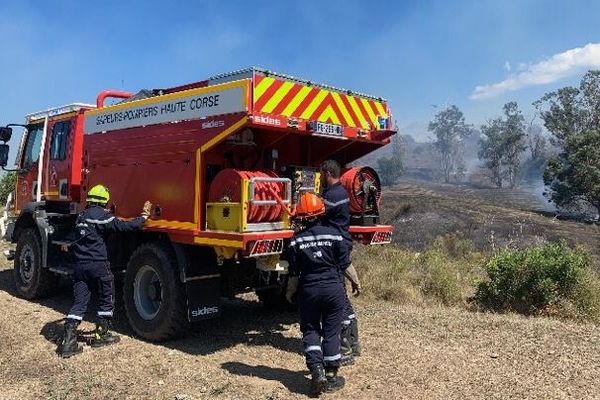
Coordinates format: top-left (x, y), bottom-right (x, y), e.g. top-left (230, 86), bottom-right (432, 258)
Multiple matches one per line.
top-left (320, 160), bottom-right (362, 365)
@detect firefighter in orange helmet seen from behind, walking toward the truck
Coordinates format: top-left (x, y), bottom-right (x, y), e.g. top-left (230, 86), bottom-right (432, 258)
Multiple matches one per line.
top-left (286, 193), bottom-right (350, 394)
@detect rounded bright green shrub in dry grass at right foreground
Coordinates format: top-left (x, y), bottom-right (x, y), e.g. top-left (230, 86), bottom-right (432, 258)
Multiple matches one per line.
top-left (475, 243), bottom-right (590, 314)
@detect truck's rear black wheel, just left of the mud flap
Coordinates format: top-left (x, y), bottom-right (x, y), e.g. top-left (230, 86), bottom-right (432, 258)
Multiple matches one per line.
top-left (123, 243), bottom-right (188, 342)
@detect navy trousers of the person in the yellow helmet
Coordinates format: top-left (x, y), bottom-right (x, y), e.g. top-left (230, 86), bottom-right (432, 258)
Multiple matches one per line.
top-left (67, 261), bottom-right (115, 321)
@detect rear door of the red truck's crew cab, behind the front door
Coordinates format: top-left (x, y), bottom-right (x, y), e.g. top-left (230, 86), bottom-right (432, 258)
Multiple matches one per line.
top-left (42, 119), bottom-right (74, 200)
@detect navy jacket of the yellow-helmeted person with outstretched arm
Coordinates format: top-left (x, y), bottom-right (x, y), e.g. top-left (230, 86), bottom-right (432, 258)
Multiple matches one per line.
top-left (71, 205), bottom-right (144, 264)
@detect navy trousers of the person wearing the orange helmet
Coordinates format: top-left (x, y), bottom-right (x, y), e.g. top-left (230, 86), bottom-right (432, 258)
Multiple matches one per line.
top-left (298, 282), bottom-right (347, 369)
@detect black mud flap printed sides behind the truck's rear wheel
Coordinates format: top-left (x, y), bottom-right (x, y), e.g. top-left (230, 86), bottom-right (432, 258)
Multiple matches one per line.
top-left (185, 274), bottom-right (221, 322)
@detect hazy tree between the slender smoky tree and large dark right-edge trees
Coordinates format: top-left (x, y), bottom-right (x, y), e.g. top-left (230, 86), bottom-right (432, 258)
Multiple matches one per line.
top-left (478, 102), bottom-right (527, 188)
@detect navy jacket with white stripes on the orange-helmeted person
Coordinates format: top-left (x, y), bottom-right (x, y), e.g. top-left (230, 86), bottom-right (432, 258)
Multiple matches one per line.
top-left (288, 223), bottom-right (350, 286)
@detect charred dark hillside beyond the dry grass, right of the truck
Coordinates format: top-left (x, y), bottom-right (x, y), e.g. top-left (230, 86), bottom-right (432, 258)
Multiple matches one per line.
top-left (383, 180), bottom-right (600, 256)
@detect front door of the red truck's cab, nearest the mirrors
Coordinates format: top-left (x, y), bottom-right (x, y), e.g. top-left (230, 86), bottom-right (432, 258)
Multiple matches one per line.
top-left (15, 122), bottom-right (44, 210)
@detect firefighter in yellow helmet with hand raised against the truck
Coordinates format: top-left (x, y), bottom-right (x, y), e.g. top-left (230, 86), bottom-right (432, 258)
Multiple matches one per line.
top-left (58, 185), bottom-right (152, 358)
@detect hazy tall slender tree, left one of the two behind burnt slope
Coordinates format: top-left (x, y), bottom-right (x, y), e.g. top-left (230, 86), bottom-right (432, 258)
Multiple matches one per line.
top-left (428, 105), bottom-right (471, 183)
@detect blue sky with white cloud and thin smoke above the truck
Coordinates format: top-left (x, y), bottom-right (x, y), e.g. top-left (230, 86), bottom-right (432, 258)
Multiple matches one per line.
top-left (0, 0), bottom-right (600, 157)
